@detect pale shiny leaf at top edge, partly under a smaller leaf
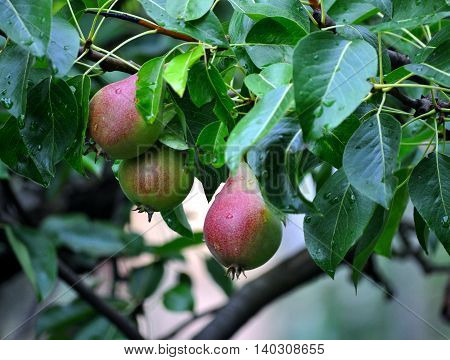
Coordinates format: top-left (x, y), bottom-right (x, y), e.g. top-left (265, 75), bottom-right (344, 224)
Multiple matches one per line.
top-left (139, 0), bottom-right (228, 47)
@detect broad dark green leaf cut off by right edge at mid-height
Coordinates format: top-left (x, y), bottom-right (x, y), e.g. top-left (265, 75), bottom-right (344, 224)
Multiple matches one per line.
top-left (409, 153), bottom-right (450, 254)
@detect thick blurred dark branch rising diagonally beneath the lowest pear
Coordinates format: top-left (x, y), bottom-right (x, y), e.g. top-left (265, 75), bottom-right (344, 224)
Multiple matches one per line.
top-left (194, 250), bottom-right (324, 340)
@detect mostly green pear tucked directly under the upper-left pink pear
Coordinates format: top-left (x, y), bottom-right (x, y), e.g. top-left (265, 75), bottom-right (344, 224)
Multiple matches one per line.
top-left (118, 146), bottom-right (194, 212)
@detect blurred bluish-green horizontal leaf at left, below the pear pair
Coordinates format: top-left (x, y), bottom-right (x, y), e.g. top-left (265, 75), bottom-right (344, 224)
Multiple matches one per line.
top-left (41, 215), bottom-right (143, 258)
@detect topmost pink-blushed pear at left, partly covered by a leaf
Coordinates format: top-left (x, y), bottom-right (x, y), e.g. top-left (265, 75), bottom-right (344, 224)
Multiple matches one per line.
top-left (89, 75), bottom-right (162, 159)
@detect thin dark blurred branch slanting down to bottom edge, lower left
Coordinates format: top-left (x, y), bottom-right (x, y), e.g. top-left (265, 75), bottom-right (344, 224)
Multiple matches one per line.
top-left (58, 260), bottom-right (144, 340)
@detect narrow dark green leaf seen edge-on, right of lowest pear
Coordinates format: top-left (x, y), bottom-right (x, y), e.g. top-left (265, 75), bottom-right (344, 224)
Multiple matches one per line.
top-left (352, 206), bottom-right (386, 288)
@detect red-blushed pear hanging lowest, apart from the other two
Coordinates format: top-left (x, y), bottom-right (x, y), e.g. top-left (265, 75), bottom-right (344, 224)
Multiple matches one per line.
top-left (203, 163), bottom-right (282, 278)
